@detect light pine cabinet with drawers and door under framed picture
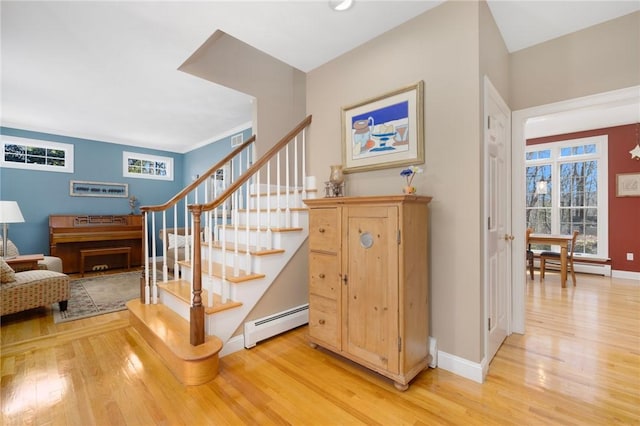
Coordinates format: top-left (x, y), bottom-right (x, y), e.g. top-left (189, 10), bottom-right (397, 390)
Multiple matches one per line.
top-left (305, 195), bottom-right (431, 390)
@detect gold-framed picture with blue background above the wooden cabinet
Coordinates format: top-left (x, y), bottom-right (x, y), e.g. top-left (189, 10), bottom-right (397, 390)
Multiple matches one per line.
top-left (342, 81), bottom-right (424, 173)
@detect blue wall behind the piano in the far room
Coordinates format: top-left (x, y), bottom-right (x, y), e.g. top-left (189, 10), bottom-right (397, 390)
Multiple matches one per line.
top-left (0, 127), bottom-right (251, 254)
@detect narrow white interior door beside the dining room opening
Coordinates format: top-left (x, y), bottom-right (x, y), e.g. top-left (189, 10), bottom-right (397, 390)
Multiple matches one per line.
top-left (484, 77), bottom-right (513, 363)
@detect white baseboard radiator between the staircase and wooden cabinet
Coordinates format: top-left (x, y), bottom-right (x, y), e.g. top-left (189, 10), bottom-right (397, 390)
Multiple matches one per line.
top-left (244, 303), bottom-right (309, 349)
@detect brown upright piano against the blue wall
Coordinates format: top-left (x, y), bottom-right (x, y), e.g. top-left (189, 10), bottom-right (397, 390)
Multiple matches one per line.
top-left (49, 214), bottom-right (144, 273)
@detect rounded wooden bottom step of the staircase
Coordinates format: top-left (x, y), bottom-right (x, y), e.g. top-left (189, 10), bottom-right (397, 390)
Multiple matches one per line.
top-left (127, 299), bottom-right (222, 386)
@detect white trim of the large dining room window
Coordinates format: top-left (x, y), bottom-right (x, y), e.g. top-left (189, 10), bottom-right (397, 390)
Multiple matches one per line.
top-left (525, 135), bottom-right (609, 259)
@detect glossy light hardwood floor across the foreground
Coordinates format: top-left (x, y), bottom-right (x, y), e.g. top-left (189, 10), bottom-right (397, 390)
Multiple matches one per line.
top-left (1, 274), bottom-right (640, 425)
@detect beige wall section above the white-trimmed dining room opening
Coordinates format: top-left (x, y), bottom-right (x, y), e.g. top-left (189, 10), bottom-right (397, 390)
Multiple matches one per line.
top-left (509, 12), bottom-right (640, 111)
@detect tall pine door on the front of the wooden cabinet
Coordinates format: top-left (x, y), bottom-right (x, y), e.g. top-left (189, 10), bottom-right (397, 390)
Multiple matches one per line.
top-left (342, 206), bottom-right (399, 373)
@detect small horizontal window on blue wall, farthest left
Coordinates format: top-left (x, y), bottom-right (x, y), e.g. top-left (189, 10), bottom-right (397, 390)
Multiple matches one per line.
top-left (0, 135), bottom-right (73, 173)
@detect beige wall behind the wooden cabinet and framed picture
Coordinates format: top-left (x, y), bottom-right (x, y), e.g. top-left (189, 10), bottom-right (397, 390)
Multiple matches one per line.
top-left (307, 2), bottom-right (482, 362)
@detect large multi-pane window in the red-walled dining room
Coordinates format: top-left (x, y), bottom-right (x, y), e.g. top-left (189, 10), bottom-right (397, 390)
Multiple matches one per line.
top-left (525, 136), bottom-right (609, 257)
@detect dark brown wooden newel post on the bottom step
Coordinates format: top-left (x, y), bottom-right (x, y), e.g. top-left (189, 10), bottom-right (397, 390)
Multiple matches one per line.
top-left (189, 204), bottom-right (204, 346)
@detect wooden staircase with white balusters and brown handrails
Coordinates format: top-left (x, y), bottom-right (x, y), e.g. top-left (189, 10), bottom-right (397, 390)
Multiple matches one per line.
top-left (127, 116), bottom-right (315, 385)
